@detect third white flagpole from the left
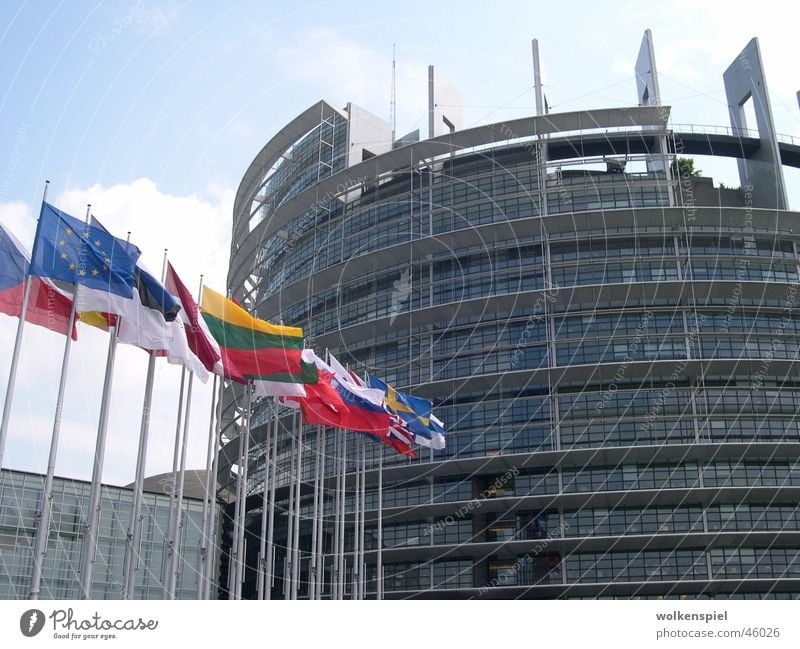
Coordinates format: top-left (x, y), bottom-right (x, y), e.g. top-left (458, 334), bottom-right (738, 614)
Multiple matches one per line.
top-left (80, 316), bottom-right (122, 599)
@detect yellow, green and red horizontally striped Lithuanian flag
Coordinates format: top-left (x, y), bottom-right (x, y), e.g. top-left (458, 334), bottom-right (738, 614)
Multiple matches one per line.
top-left (200, 287), bottom-right (318, 383)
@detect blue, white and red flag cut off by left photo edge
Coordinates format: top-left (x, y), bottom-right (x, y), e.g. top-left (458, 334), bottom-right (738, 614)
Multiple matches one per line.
top-left (0, 225), bottom-right (78, 340)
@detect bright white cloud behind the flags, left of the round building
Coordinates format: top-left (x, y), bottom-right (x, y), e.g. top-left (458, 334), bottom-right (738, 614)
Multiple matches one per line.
top-left (0, 178), bottom-right (233, 484)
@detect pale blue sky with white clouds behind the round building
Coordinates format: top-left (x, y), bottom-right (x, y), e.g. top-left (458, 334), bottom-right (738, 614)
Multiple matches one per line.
top-left (0, 0), bottom-right (800, 483)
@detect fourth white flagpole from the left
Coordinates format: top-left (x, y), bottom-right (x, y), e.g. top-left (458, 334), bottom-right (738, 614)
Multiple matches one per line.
top-left (122, 249), bottom-right (167, 599)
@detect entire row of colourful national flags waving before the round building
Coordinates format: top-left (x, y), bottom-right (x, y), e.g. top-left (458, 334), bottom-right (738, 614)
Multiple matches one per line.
top-left (0, 202), bottom-right (445, 457)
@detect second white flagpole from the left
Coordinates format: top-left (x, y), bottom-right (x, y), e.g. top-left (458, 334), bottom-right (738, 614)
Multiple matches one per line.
top-left (26, 197), bottom-right (84, 600)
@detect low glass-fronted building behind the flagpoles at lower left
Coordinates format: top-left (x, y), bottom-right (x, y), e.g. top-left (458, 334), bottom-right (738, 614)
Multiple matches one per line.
top-left (0, 469), bottom-right (212, 599)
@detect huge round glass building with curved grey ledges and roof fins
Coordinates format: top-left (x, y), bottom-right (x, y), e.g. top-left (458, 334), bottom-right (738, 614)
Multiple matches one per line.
top-left (218, 32), bottom-right (800, 598)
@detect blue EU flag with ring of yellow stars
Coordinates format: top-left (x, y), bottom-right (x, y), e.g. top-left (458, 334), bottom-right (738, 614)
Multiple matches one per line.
top-left (30, 203), bottom-right (141, 298)
